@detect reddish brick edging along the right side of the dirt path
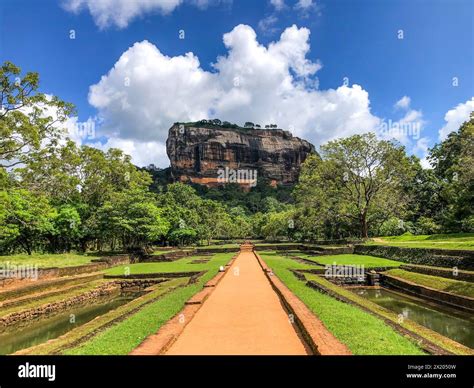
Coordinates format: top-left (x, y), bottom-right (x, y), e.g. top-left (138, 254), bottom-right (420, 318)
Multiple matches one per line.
top-left (254, 252), bottom-right (352, 355)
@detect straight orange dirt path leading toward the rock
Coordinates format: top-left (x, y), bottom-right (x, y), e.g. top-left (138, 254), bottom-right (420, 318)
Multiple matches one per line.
top-left (166, 251), bottom-right (308, 355)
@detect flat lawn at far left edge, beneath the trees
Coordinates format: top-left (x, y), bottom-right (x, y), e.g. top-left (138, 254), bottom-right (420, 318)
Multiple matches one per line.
top-left (0, 253), bottom-right (99, 268)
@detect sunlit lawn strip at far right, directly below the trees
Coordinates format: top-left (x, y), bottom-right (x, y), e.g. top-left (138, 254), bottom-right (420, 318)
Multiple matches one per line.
top-left (367, 233), bottom-right (474, 250)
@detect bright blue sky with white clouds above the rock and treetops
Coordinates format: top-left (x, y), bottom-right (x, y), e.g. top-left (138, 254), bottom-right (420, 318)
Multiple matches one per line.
top-left (0, 0), bottom-right (474, 166)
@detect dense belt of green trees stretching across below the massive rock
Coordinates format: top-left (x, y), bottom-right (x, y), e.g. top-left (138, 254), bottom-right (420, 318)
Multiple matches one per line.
top-left (0, 62), bottom-right (474, 253)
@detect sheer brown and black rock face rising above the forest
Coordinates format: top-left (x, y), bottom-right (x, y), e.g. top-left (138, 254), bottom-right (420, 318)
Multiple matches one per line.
top-left (166, 124), bottom-right (314, 186)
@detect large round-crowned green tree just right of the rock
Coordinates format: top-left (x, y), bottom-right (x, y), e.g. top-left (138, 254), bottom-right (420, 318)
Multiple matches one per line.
top-left (295, 133), bottom-right (412, 237)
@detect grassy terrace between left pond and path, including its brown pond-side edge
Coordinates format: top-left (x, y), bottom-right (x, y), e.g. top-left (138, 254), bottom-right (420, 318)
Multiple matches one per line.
top-left (14, 253), bottom-right (233, 354)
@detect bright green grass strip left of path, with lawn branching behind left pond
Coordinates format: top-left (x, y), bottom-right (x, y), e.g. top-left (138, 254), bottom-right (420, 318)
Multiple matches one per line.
top-left (64, 253), bottom-right (234, 355)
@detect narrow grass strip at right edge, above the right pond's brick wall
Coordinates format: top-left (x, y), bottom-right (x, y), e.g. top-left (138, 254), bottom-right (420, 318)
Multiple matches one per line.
top-left (385, 268), bottom-right (474, 298)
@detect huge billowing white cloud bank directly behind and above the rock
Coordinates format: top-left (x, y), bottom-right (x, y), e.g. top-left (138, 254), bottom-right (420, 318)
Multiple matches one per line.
top-left (89, 25), bottom-right (380, 167)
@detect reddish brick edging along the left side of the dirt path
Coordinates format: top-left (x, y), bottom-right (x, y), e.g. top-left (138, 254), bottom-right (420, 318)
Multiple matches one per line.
top-left (129, 256), bottom-right (236, 356)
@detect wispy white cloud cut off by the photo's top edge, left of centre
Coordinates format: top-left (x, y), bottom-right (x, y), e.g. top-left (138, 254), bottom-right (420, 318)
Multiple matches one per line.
top-left (63, 0), bottom-right (218, 29)
